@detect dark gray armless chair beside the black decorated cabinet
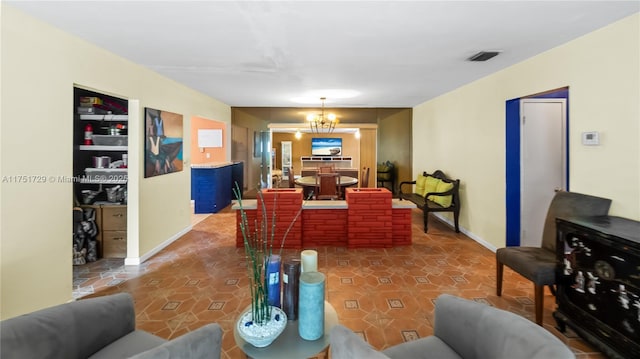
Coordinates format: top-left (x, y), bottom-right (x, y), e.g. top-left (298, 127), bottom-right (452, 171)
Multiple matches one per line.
top-left (496, 191), bottom-right (611, 325)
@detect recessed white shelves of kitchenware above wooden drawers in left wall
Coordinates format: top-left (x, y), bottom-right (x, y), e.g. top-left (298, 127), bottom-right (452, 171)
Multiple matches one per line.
top-left (73, 87), bottom-right (129, 258)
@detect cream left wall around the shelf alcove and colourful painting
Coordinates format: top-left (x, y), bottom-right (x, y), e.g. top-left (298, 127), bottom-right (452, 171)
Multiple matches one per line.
top-left (0, 3), bottom-right (231, 318)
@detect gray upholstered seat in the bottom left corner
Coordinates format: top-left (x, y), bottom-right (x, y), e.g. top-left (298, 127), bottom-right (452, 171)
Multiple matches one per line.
top-left (0, 293), bottom-right (222, 359)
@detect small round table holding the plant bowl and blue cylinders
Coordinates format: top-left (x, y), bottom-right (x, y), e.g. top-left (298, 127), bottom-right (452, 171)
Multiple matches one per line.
top-left (233, 301), bottom-right (338, 359)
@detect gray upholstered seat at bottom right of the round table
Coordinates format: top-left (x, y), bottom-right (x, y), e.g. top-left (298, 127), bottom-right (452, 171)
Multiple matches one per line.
top-left (330, 294), bottom-right (575, 359)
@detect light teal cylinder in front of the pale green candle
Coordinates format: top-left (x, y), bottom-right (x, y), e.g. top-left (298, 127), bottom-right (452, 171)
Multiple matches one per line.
top-left (298, 272), bottom-right (325, 340)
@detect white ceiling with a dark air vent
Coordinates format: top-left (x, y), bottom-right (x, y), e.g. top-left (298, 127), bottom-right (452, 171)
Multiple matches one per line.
top-left (3, 0), bottom-right (640, 107)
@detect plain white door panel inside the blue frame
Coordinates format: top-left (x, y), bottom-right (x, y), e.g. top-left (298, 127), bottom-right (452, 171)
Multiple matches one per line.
top-left (520, 98), bottom-right (566, 247)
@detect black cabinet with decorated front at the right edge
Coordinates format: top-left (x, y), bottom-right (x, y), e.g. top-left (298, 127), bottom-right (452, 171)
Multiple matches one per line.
top-left (553, 216), bottom-right (640, 358)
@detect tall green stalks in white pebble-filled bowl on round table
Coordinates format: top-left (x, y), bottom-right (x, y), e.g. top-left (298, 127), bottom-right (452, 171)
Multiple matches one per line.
top-left (233, 183), bottom-right (302, 347)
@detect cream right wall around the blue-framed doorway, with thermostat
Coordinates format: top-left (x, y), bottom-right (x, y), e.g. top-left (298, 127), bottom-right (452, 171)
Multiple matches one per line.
top-left (413, 14), bottom-right (640, 248)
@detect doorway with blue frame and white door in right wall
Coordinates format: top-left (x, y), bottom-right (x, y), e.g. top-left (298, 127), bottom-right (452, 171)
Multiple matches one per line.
top-left (506, 89), bottom-right (569, 247)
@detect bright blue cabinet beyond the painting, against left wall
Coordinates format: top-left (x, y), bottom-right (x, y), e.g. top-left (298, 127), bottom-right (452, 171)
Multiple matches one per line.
top-left (191, 165), bottom-right (232, 213)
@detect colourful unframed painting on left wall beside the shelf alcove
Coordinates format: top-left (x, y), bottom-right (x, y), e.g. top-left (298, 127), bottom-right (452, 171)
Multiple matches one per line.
top-left (144, 107), bottom-right (183, 178)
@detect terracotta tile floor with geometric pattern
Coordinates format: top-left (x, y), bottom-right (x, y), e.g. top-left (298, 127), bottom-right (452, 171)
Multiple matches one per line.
top-left (74, 210), bottom-right (605, 359)
